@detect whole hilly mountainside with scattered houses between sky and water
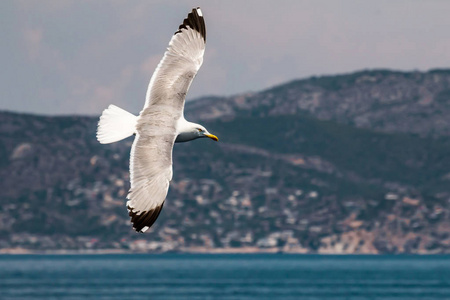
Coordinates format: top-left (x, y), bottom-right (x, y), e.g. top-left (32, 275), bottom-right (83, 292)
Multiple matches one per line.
top-left (0, 70), bottom-right (450, 253)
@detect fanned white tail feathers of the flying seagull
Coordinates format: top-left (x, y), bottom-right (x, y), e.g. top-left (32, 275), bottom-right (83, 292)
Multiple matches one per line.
top-left (97, 104), bottom-right (137, 144)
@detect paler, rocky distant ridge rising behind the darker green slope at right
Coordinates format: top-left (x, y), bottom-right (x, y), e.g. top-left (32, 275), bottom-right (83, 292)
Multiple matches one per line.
top-left (188, 70), bottom-right (450, 137)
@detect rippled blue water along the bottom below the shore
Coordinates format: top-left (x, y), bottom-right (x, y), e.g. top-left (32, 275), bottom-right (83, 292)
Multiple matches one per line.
top-left (0, 254), bottom-right (450, 300)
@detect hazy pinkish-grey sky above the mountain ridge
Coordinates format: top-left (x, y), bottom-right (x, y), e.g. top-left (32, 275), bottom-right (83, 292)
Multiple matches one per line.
top-left (0, 0), bottom-right (450, 115)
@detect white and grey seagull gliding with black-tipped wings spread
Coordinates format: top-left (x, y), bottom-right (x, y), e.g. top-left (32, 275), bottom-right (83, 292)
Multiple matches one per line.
top-left (97, 7), bottom-right (219, 232)
